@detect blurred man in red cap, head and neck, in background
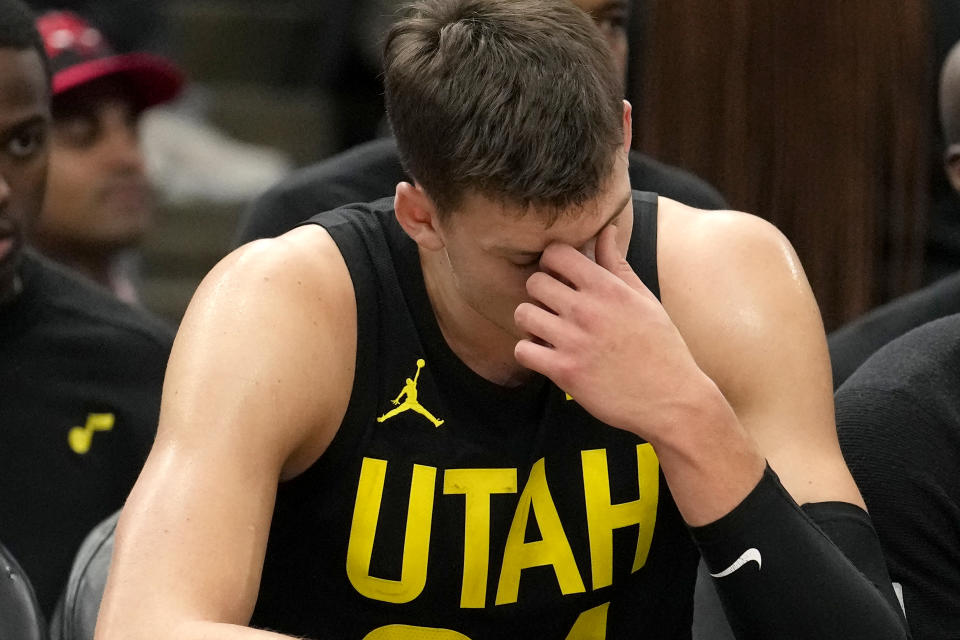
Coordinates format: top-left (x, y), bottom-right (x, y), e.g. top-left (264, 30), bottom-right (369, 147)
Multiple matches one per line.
top-left (31, 11), bottom-right (182, 301)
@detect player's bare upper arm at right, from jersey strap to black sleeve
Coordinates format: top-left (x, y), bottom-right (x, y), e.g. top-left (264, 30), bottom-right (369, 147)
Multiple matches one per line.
top-left (657, 198), bottom-right (861, 504)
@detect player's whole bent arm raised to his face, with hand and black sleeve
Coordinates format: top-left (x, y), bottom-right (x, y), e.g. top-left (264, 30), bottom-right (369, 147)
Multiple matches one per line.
top-left (517, 200), bottom-right (905, 638)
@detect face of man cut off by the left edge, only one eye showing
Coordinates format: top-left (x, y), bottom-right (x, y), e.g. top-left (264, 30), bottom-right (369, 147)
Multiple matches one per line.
top-left (0, 48), bottom-right (50, 302)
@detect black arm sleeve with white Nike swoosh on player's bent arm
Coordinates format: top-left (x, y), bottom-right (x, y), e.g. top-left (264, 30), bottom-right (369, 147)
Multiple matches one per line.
top-left (691, 466), bottom-right (909, 640)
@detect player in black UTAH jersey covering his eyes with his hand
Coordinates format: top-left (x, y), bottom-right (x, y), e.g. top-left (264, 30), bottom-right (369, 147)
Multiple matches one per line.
top-left (97, 0), bottom-right (906, 640)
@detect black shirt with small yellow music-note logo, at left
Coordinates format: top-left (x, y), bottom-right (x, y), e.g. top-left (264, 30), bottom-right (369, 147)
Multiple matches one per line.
top-left (0, 254), bottom-right (173, 617)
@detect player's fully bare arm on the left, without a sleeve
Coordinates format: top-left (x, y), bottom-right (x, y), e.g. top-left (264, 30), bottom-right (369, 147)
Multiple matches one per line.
top-left (96, 228), bottom-right (355, 640)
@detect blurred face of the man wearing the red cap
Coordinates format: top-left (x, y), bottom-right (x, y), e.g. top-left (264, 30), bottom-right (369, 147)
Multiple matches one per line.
top-left (34, 79), bottom-right (153, 254)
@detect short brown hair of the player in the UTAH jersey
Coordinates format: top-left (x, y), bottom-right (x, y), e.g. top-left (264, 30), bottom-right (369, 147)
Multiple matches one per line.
top-left (384, 0), bottom-right (623, 214)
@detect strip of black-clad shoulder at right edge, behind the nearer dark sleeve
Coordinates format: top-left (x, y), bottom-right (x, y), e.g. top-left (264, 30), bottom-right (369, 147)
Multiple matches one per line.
top-left (827, 272), bottom-right (960, 389)
